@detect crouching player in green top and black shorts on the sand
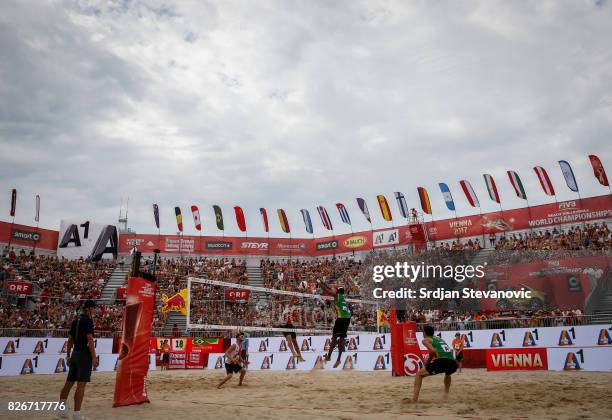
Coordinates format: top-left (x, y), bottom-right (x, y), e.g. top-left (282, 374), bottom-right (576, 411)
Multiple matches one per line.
top-left (412, 325), bottom-right (457, 403)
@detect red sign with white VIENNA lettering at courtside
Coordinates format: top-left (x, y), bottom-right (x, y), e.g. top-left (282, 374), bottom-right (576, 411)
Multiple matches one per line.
top-left (486, 348), bottom-right (548, 370)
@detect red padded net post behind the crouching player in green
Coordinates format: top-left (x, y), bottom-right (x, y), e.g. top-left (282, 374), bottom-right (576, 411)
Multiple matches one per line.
top-left (389, 309), bottom-right (424, 376)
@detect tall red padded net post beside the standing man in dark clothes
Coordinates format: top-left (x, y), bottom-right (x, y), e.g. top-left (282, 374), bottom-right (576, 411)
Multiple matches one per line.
top-left (113, 277), bottom-right (157, 407)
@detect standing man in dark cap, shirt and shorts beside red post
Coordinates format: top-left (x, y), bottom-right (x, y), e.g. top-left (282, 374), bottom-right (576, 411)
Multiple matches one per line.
top-left (58, 300), bottom-right (99, 419)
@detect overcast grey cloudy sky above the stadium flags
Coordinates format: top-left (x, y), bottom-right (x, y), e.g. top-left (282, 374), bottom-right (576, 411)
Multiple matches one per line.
top-left (0, 0), bottom-right (612, 236)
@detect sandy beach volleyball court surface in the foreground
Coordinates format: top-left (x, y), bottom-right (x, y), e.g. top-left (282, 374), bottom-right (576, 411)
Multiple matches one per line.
top-left (0, 370), bottom-right (612, 420)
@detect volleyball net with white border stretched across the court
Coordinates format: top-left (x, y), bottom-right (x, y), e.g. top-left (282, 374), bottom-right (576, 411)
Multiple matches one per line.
top-left (187, 277), bottom-right (379, 335)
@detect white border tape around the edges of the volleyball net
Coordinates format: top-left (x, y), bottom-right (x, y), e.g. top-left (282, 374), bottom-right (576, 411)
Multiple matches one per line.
top-left (187, 277), bottom-right (380, 335)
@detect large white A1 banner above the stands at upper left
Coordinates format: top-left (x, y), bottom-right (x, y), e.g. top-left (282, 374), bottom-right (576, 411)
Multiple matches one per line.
top-left (57, 220), bottom-right (119, 260)
